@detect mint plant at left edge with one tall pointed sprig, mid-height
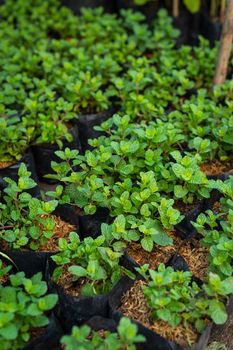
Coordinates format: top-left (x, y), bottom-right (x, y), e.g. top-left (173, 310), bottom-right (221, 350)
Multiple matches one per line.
top-left (0, 163), bottom-right (58, 250)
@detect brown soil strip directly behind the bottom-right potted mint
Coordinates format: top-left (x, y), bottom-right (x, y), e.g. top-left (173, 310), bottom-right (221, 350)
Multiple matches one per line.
top-left (126, 231), bottom-right (208, 280)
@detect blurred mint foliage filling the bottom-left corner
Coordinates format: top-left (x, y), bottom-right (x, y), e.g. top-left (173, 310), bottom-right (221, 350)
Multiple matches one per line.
top-left (0, 272), bottom-right (58, 350)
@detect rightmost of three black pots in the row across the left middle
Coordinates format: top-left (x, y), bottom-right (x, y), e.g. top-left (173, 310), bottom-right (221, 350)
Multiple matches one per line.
top-left (74, 108), bottom-right (115, 152)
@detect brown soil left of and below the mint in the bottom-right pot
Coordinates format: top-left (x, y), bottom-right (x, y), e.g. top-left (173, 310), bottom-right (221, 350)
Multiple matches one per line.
top-left (118, 280), bottom-right (198, 347)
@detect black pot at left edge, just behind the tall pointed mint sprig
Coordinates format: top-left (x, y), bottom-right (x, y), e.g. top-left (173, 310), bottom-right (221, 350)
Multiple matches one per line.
top-left (0, 150), bottom-right (40, 197)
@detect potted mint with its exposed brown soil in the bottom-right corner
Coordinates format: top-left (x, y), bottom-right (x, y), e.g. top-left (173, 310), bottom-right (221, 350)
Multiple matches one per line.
top-left (110, 264), bottom-right (232, 349)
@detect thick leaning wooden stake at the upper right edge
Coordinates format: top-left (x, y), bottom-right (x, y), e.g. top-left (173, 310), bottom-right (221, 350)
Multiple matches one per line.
top-left (214, 0), bottom-right (233, 85)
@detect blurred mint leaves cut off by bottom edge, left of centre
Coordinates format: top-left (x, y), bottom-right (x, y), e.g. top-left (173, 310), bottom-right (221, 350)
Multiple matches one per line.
top-left (61, 317), bottom-right (145, 350)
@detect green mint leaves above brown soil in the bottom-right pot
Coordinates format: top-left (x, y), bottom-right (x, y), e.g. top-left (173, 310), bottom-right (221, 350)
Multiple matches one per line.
top-left (137, 264), bottom-right (233, 332)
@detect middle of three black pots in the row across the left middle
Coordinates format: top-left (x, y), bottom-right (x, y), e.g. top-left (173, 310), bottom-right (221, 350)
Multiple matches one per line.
top-left (32, 126), bottom-right (81, 183)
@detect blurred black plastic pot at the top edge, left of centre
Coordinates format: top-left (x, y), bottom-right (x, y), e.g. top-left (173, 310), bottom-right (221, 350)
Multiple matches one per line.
top-left (60, 0), bottom-right (114, 15)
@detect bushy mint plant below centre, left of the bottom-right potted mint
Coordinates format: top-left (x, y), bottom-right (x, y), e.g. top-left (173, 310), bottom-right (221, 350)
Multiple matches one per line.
top-left (52, 232), bottom-right (126, 296)
